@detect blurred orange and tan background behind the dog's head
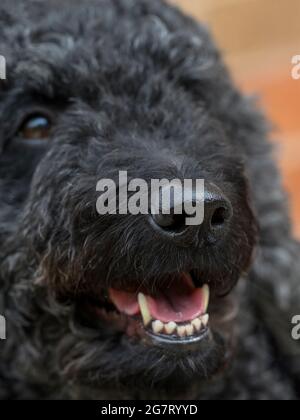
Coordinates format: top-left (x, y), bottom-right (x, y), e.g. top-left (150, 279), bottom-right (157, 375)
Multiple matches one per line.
top-left (169, 0), bottom-right (300, 237)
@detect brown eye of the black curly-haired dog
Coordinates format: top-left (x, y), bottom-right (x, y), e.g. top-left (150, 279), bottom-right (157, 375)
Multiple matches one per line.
top-left (20, 115), bottom-right (51, 140)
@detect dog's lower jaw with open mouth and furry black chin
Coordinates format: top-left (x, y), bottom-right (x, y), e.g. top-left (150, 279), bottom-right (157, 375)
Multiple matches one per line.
top-left (66, 273), bottom-right (238, 392)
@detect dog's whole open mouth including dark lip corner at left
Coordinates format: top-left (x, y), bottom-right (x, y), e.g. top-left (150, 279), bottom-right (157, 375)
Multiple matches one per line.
top-left (88, 273), bottom-right (210, 344)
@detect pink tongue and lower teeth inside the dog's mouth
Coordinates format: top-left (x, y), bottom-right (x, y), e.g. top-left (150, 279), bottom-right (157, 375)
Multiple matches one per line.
top-left (109, 273), bottom-right (209, 342)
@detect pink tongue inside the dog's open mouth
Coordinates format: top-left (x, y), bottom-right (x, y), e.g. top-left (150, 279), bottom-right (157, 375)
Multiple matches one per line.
top-left (110, 275), bottom-right (204, 322)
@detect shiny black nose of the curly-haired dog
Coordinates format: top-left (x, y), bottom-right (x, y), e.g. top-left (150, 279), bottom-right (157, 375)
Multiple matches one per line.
top-left (151, 184), bottom-right (233, 243)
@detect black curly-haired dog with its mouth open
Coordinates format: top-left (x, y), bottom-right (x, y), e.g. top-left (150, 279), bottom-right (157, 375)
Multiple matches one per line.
top-left (0, 0), bottom-right (300, 399)
